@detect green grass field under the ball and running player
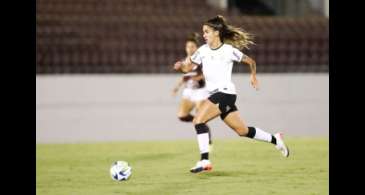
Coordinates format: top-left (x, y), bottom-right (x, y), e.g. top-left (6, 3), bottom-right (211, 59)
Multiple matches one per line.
top-left (36, 138), bottom-right (329, 195)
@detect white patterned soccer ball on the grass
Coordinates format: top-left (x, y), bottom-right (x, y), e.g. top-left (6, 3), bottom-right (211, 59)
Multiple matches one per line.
top-left (110, 161), bottom-right (132, 181)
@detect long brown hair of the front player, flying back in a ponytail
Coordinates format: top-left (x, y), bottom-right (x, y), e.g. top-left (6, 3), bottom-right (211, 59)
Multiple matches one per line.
top-left (204, 15), bottom-right (254, 50)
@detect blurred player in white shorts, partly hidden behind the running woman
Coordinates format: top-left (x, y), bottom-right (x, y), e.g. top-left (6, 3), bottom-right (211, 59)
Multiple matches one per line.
top-left (172, 33), bottom-right (212, 144)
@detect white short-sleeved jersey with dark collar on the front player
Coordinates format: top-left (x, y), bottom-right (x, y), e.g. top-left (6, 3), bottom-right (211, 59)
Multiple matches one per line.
top-left (190, 43), bottom-right (247, 94)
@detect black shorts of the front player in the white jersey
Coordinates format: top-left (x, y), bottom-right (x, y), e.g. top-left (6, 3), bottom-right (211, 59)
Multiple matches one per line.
top-left (208, 92), bottom-right (237, 120)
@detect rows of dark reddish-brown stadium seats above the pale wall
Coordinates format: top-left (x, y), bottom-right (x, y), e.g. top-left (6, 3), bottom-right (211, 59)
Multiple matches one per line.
top-left (36, 0), bottom-right (329, 73)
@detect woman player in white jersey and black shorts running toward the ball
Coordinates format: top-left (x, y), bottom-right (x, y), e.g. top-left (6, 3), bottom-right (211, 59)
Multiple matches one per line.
top-left (174, 15), bottom-right (289, 173)
